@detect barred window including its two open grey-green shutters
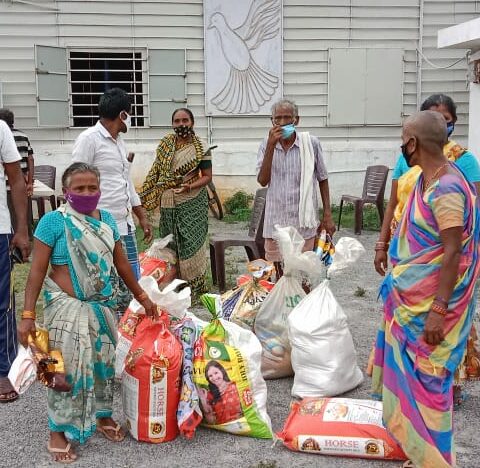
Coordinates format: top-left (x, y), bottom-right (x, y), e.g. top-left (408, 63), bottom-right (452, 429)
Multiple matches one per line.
top-left (35, 44), bottom-right (187, 128)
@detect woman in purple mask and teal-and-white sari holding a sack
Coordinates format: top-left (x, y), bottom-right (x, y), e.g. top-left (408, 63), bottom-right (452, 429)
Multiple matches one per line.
top-left (18, 163), bottom-right (156, 463)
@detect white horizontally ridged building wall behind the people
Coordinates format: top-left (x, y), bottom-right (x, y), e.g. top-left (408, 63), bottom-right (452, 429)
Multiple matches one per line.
top-left (0, 0), bottom-right (480, 206)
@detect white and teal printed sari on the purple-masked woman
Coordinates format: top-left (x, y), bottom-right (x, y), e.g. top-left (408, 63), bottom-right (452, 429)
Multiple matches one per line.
top-left (44, 204), bottom-right (117, 443)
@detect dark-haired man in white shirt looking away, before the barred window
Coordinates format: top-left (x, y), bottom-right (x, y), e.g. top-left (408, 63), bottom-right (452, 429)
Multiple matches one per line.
top-left (73, 88), bottom-right (153, 314)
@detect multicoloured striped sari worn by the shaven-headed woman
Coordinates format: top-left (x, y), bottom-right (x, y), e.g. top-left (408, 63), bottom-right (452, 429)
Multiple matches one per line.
top-left (372, 173), bottom-right (480, 468)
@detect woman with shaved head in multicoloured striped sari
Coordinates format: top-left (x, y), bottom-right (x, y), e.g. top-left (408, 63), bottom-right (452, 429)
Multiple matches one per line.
top-left (373, 111), bottom-right (480, 468)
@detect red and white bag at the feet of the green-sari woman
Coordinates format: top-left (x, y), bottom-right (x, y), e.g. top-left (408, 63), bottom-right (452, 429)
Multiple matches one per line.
top-left (139, 234), bottom-right (177, 288)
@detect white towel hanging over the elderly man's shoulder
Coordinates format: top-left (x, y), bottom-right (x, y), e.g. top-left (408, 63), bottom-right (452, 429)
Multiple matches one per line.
top-left (298, 132), bottom-right (318, 229)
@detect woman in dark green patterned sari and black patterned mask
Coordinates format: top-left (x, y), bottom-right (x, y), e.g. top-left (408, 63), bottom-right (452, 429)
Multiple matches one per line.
top-left (139, 108), bottom-right (212, 295)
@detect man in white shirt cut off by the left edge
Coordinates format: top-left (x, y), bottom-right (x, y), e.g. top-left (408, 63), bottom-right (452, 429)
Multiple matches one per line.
top-left (0, 120), bottom-right (30, 403)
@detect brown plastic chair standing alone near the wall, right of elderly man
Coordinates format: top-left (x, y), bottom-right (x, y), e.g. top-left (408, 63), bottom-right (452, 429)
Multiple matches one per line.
top-left (338, 166), bottom-right (389, 234)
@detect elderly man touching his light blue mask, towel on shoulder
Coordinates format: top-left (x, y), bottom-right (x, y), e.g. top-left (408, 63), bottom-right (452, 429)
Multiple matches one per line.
top-left (257, 99), bottom-right (335, 277)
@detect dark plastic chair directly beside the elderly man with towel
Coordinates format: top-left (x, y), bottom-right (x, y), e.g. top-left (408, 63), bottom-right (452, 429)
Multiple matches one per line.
top-left (210, 188), bottom-right (267, 292)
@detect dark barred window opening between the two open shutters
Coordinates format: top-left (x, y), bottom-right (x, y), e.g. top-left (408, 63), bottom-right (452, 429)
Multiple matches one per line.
top-left (69, 50), bottom-right (147, 127)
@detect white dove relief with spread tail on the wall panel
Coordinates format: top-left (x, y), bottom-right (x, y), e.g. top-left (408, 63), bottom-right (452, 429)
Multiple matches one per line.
top-left (207, 0), bottom-right (282, 114)
